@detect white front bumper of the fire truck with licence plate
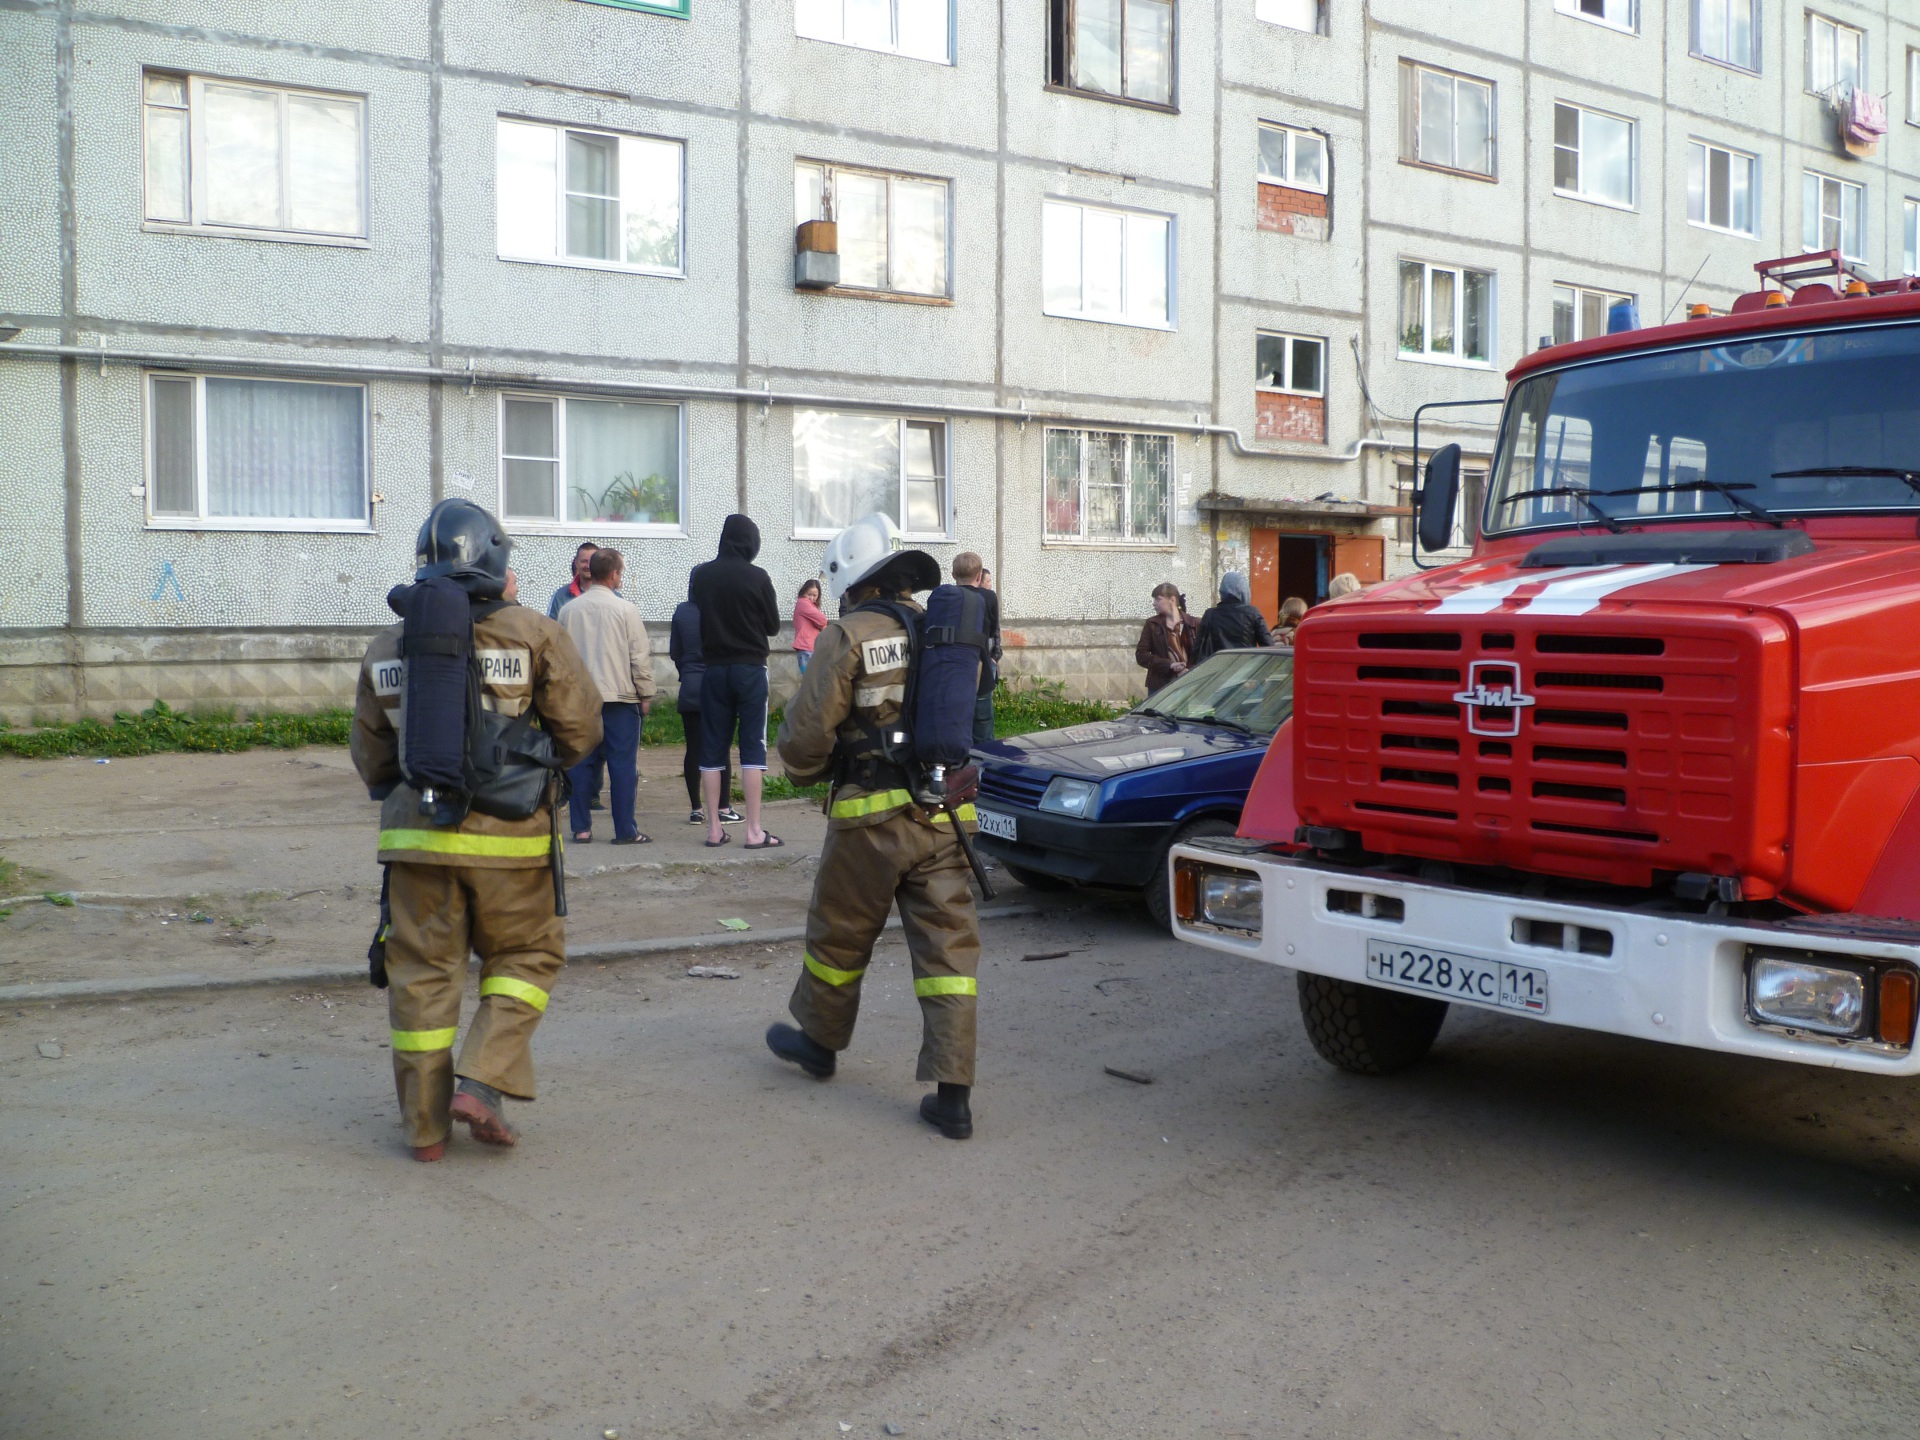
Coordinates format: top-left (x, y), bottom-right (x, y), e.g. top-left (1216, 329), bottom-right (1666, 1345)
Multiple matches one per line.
top-left (1169, 839), bottom-right (1920, 1075)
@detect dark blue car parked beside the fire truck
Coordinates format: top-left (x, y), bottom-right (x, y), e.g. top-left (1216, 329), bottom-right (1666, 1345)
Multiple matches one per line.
top-left (973, 649), bottom-right (1294, 925)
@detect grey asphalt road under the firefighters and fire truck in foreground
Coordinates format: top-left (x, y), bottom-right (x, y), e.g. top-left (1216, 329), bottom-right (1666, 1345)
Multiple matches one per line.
top-left (0, 906), bottom-right (1920, 1440)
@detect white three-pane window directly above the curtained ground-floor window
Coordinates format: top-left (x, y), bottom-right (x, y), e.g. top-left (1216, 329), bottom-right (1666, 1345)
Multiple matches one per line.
top-left (146, 71), bottom-right (367, 240)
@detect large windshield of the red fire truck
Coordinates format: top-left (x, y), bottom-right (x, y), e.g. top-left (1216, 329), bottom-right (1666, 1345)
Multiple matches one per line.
top-left (1486, 323), bottom-right (1920, 534)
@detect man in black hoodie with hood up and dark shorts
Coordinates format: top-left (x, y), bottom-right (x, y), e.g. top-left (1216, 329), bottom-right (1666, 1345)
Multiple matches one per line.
top-left (687, 515), bottom-right (781, 851)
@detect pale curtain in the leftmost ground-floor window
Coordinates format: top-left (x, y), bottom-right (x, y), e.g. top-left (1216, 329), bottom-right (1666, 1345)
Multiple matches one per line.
top-left (207, 378), bottom-right (367, 520)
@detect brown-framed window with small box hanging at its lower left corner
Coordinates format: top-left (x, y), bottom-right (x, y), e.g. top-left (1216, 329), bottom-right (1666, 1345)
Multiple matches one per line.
top-left (793, 159), bottom-right (948, 296)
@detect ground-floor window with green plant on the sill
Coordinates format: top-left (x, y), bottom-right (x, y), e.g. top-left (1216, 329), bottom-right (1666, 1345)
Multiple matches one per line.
top-left (499, 394), bottom-right (684, 534)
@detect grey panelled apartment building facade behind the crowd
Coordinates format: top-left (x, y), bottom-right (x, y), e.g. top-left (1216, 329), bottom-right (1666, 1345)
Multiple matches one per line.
top-left (0, 0), bottom-right (1920, 722)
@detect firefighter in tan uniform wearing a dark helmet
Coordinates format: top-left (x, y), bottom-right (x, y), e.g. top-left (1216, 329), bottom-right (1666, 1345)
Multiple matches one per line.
top-left (351, 499), bottom-right (601, 1160)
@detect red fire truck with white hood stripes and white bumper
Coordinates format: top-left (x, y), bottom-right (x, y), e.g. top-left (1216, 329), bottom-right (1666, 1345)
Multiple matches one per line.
top-left (1171, 253), bottom-right (1920, 1075)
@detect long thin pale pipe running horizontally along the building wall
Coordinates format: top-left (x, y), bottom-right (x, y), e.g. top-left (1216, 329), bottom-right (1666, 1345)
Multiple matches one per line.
top-left (0, 344), bottom-right (1405, 465)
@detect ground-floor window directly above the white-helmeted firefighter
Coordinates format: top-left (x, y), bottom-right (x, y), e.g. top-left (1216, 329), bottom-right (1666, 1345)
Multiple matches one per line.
top-left (793, 411), bottom-right (947, 540)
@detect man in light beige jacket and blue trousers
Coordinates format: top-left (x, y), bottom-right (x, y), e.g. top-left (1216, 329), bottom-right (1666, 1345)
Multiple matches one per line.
top-left (561, 549), bottom-right (653, 845)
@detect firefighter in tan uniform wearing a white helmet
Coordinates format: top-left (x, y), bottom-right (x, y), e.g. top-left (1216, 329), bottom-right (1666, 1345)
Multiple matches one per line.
top-left (766, 515), bottom-right (979, 1140)
